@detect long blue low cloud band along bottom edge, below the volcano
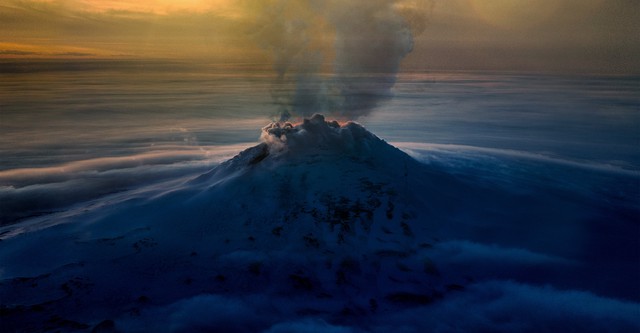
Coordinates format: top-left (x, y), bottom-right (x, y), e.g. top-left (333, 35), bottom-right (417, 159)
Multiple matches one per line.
top-left (116, 280), bottom-right (640, 333)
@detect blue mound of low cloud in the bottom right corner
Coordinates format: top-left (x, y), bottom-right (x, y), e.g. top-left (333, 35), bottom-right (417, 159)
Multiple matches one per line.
top-left (372, 281), bottom-right (640, 332)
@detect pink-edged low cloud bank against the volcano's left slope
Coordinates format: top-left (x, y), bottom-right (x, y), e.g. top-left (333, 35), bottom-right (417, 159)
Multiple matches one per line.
top-left (0, 145), bottom-right (246, 226)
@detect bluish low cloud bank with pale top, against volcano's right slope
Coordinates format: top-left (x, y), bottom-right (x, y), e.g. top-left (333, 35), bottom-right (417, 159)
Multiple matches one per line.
top-left (393, 142), bottom-right (640, 211)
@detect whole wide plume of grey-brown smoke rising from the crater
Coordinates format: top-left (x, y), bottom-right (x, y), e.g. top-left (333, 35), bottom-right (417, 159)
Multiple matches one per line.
top-left (248, 0), bottom-right (431, 121)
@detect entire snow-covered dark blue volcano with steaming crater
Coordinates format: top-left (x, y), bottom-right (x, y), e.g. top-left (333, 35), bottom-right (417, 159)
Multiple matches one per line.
top-left (0, 115), bottom-right (640, 332)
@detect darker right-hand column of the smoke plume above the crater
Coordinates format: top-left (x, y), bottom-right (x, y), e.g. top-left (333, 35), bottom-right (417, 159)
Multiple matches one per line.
top-left (331, 0), bottom-right (413, 118)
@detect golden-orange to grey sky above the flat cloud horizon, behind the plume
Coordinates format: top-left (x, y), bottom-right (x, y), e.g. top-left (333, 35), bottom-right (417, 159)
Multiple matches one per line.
top-left (0, 0), bottom-right (640, 74)
